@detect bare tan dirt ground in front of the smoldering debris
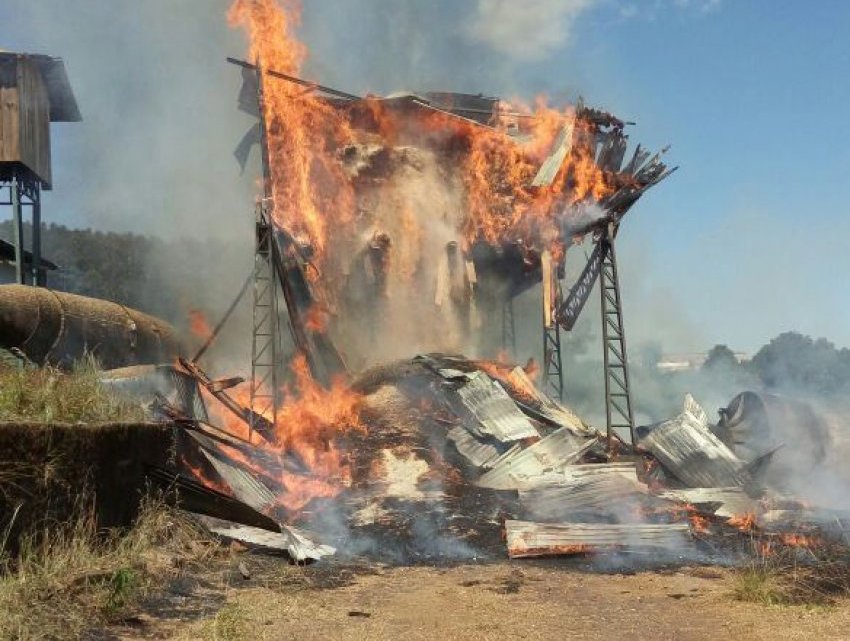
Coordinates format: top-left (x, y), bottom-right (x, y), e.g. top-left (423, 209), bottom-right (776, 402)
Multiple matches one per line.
top-left (107, 556), bottom-right (850, 641)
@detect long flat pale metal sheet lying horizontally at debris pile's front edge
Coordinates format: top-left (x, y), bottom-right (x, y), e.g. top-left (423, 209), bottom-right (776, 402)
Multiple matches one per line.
top-left (505, 521), bottom-right (689, 559)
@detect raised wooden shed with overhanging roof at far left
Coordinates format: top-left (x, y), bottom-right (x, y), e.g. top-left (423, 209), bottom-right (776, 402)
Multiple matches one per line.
top-left (0, 51), bottom-right (82, 189)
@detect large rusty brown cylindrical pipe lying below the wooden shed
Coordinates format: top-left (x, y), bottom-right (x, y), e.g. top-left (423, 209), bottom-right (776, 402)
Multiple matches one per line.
top-left (0, 285), bottom-right (180, 369)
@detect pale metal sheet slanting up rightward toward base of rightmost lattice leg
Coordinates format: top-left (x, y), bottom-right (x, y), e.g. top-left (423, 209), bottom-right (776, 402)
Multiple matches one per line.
top-left (477, 428), bottom-right (597, 490)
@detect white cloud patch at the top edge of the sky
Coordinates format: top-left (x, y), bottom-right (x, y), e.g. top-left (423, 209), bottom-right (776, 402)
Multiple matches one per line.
top-left (466, 0), bottom-right (599, 61)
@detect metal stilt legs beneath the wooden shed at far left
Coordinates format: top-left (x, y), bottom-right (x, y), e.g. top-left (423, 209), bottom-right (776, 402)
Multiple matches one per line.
top-left (0, 170), bottom-right (47, 285)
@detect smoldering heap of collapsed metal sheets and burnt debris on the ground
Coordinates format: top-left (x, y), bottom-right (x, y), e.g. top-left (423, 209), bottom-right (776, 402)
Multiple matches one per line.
top-left (136, 354), bottom-right (850, 563)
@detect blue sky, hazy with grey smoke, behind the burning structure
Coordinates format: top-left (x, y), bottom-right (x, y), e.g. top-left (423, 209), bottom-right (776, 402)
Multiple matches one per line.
top-left (0, 0), bottom-right (850, 351)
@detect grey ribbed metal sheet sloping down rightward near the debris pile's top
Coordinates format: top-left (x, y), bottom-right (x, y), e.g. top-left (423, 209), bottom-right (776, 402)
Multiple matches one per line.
top-left (455, 372), bottom-right (540, 443)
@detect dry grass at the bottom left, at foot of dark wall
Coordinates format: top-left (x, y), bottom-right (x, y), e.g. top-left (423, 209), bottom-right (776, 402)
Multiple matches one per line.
top-left (0, 498), bottom-right (215, 641)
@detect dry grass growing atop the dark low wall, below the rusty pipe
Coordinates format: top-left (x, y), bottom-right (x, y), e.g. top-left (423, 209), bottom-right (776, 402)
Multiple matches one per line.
top-left (0, 358), bottom-right (144, 423)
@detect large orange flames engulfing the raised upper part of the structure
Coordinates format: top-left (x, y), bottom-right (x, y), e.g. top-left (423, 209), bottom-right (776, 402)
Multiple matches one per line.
top-left (228, 0), bottom-right (618, 306)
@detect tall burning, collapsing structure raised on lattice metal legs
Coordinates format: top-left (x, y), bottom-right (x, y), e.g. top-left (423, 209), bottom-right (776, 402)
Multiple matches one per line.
top-left (222, 59), bottom-right (673, 444)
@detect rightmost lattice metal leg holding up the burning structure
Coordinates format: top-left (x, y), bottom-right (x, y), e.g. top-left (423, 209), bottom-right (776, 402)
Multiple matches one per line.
top-left (599, 229), bottom-right (635, 447)
